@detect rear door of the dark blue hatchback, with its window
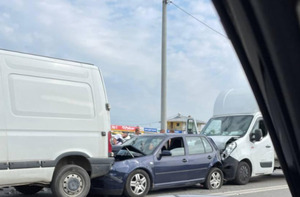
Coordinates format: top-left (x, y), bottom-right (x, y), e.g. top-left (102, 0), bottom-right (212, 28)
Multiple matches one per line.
top-left (186, 136), bottom-right (213, 180)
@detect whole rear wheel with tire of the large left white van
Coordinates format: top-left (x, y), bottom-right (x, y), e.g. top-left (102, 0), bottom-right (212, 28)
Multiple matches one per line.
top-left (51, 165), bottom-right (91, 197)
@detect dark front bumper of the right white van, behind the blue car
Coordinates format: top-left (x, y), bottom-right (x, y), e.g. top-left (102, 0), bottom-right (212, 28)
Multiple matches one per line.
top-left (222, 156), bottom-right (239, 181)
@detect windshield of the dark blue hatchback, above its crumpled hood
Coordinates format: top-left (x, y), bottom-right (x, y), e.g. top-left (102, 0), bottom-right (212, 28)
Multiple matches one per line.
top-left (123, 135), bottom-right (165, 155)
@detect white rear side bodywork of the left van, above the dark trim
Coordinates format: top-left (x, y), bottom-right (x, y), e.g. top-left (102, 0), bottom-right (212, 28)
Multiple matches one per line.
top-left (0, 54), bottom-right (109, 163)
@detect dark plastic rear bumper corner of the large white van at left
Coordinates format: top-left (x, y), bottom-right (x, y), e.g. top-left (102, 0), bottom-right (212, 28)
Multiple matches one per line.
top-left (88, 158), bottom-right (115, 178)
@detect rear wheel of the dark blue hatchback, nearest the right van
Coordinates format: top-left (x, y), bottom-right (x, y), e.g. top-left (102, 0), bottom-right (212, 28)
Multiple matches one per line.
top-left (204, 168), bottom-right (224, 189)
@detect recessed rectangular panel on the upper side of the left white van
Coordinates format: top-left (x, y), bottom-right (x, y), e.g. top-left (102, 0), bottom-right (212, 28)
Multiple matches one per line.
top-left (8, 74), bottom-right (95, 119)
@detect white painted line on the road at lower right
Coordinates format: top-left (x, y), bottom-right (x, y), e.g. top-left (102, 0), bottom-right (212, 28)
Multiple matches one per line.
top-left (210, 185), bottom-right (289, 196)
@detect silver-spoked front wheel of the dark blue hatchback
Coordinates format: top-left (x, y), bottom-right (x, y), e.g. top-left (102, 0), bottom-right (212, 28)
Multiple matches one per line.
top-left (124, 170), bottom-right (151, 197)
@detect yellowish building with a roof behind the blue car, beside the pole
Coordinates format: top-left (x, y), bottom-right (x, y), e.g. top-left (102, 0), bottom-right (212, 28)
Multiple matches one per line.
top-left (167, 113), bottom-right (205, 133)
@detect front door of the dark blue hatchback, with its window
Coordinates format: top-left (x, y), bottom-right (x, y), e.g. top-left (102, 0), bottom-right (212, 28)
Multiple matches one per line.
top-left (154, 137), bottom-right (187, 186)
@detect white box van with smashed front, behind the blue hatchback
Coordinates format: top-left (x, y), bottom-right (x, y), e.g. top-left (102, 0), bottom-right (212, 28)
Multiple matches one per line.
top-left (201, 90), bottom-right (280, 185)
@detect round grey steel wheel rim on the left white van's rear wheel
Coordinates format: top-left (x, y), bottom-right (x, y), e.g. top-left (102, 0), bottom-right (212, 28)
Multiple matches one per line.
top-left (63, 174), bottom-right (83, 195)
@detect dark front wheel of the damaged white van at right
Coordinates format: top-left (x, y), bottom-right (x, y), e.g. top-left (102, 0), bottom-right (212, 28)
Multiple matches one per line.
top-left (234, 161), bottom-right (251, 185)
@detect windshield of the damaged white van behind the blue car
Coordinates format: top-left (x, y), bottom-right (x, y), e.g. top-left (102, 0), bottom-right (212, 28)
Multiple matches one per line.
top-left (201, 115), bottom-right (253, 137)
